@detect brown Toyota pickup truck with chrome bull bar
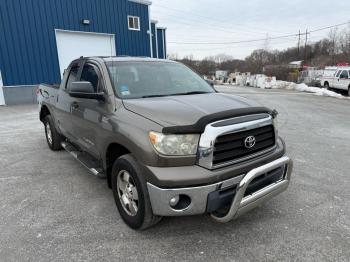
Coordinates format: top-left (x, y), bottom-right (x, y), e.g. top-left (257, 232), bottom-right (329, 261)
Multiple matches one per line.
top-left (38, 57), bottom-right (292, 230)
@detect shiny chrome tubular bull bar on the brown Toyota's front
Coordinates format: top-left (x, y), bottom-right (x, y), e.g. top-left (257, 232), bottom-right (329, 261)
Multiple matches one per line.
top-left (211, 156), bottom-right (293, 223)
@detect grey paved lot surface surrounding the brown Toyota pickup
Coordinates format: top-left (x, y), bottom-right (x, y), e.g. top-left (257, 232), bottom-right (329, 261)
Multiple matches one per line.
top-left (0, 87), bottom-right (350, 261)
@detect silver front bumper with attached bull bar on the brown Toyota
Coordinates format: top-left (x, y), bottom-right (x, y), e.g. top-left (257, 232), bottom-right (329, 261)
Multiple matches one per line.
top-left (147, 156), bottom-right (293, 222)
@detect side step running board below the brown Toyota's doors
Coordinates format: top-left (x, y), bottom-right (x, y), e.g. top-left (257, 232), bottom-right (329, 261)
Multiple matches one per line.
top-left (61, 141), bottom-right (106, 178)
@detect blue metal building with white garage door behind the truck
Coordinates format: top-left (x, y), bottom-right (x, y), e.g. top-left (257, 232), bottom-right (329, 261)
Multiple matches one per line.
top-left (0, 0), bottom-right (166, 104)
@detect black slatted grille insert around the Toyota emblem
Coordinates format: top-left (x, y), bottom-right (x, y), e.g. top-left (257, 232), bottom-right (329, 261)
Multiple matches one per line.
top-left (213, 125), bottom-right (276, 166)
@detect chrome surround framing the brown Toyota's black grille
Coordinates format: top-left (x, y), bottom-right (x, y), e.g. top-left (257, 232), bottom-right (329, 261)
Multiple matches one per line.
top-left (197, 114), bottom-right (277, 169)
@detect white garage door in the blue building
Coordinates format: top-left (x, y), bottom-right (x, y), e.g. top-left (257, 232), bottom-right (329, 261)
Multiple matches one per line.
top-left (56, 30), bottom-right (116, 76)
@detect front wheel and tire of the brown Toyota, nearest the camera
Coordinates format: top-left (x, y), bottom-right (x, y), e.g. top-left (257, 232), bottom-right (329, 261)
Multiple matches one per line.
top-left (112, 154), bottom-right (161, 230)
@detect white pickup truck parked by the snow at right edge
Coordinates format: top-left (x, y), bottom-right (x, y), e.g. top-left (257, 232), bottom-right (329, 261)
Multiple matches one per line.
top-left (321, 67), bottom-right (350, 96)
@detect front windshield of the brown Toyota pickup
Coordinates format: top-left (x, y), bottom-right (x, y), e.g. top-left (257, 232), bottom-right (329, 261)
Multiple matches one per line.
top-left (106, 62), bottom-right (215, 99)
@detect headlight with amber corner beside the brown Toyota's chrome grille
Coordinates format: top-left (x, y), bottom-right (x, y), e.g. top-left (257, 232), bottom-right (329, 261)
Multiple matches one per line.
top-left (149, 132), bottom-right (199, 156)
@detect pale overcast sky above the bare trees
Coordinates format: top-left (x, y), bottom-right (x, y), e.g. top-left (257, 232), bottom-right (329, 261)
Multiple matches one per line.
top-left (151, 0), bottom-right (350, 59)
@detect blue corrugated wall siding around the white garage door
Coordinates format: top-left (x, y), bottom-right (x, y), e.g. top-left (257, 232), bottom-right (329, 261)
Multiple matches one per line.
top-left (0, 0), bottom-right (150, 86)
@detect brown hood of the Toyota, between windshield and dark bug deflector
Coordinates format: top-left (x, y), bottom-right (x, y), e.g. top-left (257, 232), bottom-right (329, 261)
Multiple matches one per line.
top-left (123, 93), bottom-right (259, 127)
